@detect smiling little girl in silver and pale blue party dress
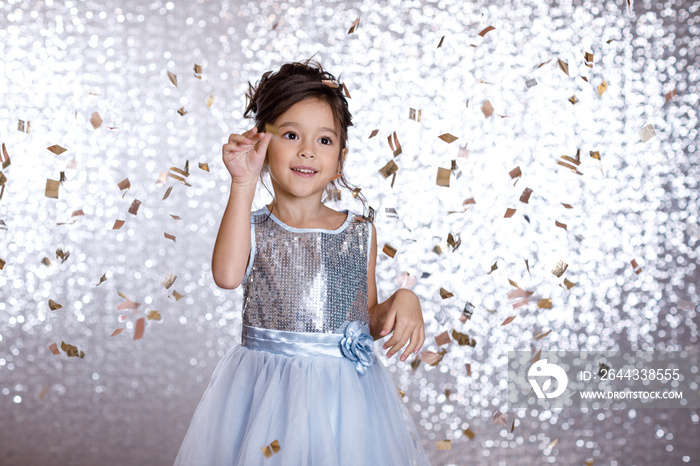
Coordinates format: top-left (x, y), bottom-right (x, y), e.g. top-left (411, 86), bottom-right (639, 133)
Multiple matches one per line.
top-left (175, 61), bottom-right (429, 466)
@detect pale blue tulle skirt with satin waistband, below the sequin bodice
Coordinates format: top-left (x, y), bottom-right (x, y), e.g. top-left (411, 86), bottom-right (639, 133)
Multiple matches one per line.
top-left (175, 325), bottom-right (430, 466)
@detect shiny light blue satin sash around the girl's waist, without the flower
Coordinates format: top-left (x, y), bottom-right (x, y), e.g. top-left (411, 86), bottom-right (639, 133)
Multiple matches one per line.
top-left (241, 324), bottom-right (345, 358)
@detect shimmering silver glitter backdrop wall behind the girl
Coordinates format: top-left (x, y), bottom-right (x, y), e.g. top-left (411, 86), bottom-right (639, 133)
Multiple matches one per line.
top-left (0, 0), bottom-right (700, 465)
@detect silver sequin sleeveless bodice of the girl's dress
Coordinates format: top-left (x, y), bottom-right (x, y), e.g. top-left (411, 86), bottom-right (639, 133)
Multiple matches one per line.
top-left (242, 206), bottom-right (372, 333)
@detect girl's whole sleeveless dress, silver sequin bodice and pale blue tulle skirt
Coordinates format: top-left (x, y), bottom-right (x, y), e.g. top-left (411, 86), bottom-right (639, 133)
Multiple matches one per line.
top-left (175, 207), bottom-right (430, 466)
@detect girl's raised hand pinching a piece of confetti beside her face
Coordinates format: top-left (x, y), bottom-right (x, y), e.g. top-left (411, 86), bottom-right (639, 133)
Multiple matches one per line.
top-left (221, 127), bottom-right (272, 184)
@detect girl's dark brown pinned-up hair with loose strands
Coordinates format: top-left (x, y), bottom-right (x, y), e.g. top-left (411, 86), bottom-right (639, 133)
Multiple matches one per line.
top-left (243, 59), bottom-right (374, 219)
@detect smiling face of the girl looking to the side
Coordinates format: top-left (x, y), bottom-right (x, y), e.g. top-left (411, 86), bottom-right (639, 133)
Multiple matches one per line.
top-left (267, 98), bottom-right (347, 201)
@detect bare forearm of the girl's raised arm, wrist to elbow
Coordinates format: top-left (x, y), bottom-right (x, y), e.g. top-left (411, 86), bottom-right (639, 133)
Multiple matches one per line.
top-left (211, 182), bottom-right (255, 290)
